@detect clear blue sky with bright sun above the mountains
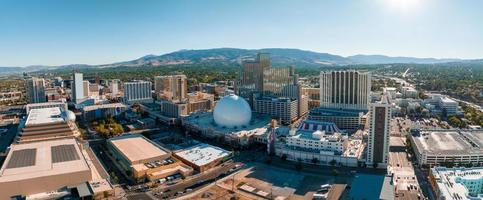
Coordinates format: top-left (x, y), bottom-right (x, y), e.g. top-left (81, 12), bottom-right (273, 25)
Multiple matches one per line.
top-left (0, 0), bottom-right (483, 66)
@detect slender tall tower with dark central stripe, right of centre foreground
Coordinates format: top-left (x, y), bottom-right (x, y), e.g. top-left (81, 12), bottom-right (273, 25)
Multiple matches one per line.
top-left (366, 94), bottom-right (391, 168)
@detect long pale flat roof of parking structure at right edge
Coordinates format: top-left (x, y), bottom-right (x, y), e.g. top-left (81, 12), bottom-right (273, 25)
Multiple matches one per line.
top-left (412, 130), bottom-right (483, 155)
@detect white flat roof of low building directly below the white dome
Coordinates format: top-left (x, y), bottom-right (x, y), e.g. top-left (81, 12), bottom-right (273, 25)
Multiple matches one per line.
top-left (175, 143), bottom-right (230, 166)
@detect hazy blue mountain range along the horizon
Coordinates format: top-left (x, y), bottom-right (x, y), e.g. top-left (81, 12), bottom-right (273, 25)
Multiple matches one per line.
top-left (0, 48), bottom-right (481, 73)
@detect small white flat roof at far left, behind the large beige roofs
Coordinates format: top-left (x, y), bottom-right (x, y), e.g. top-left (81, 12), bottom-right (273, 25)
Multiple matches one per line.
top-left (25, 107), bottom-right (65, 126)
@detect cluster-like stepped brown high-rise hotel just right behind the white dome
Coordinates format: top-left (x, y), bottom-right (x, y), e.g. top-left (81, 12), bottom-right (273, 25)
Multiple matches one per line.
top-left (235, 53), bottom-right (308, 124)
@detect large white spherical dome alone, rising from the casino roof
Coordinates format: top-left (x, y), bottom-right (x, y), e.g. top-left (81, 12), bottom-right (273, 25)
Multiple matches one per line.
top-left (213, 94), bottom-right (252, 128)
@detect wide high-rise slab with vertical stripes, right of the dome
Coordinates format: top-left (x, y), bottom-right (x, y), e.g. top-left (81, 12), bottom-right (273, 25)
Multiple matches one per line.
top-left (320, 71), bottom-right (371, 110)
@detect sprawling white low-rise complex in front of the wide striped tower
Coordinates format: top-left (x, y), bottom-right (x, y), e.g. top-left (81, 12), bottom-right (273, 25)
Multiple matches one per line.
top-left (275, 120), bottom-right (365, 167)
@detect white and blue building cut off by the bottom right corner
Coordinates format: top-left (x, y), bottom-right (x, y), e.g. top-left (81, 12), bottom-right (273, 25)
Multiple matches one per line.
top-left (429, 167), bottom-right (483, 200)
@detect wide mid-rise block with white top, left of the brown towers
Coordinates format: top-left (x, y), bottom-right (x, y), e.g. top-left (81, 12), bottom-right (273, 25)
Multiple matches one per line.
top-left (124, 81), bottom-right (153, 103)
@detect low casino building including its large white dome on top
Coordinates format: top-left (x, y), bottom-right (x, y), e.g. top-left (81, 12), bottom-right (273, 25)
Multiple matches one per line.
top-left (182, 94), bottom-right (271, 146)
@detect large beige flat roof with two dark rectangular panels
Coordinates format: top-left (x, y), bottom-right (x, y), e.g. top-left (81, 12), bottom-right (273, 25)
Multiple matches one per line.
top-left (0, 138), bottom-right (90, 184)
